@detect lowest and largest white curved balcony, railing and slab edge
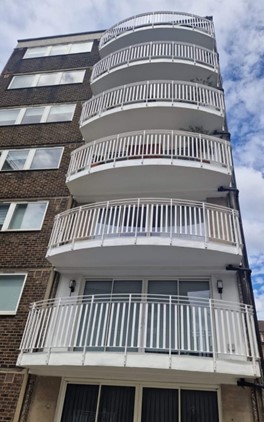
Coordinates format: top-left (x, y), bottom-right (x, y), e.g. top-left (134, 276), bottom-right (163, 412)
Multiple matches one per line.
top-left (18, 294), bottom-right (259, 376)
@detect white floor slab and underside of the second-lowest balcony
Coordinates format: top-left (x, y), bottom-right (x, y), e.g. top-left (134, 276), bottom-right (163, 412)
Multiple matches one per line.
top-left (47, 241), bottom-right (241, 272)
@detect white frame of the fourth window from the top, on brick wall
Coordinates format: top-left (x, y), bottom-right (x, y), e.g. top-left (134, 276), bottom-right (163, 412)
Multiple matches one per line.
top-left (0, 146), bottom-right (64, 172)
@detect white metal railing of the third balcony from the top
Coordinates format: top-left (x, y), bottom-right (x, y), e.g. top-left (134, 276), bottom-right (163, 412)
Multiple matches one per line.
top-left (80, 81), bottom-right (224, 126)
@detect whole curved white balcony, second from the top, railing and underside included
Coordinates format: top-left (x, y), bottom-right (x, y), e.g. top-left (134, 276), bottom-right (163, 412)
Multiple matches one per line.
top-left (91, 41), bottom-right (219, 94)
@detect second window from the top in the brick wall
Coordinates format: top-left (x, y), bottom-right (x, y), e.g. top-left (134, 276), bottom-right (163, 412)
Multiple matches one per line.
top-left (8, 70), bottom-right (85, 89)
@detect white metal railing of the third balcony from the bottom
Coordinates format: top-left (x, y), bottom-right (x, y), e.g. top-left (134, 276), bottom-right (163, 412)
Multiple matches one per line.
top-left (67, 130), bottom-right (232, 179)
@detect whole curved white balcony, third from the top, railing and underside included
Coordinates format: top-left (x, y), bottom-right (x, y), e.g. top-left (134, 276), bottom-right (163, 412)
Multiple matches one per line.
top-left (80, 81), bottom-right (224, 142)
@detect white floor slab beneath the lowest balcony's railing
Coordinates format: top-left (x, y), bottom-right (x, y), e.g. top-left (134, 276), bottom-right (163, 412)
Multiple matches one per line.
top-left (19, 352), bottom-right (259, 384)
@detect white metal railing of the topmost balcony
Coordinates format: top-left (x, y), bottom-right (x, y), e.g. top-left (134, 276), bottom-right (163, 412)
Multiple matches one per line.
top-left (99, 11), bottom-right (214, 49)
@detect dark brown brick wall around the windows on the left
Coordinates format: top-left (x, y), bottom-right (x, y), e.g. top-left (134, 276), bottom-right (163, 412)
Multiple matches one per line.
top-left (0, 31), bottom-right (98, 422)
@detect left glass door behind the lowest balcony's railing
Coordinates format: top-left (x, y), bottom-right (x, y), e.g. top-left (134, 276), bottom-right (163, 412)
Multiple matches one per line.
top-left (81, 280), bottom-right (142, 351)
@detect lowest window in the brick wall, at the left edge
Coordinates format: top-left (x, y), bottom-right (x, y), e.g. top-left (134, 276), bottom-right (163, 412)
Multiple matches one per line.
top-left (0, 274), bottom-right (26, 315)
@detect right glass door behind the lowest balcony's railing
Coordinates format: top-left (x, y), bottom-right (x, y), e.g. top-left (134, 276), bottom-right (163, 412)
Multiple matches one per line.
top-left (145, 280), bottom-right (212, 354)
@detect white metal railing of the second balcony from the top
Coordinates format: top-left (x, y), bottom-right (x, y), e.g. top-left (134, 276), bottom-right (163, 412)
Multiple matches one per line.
top-left (91, 41), bottom-right (218, 83)
